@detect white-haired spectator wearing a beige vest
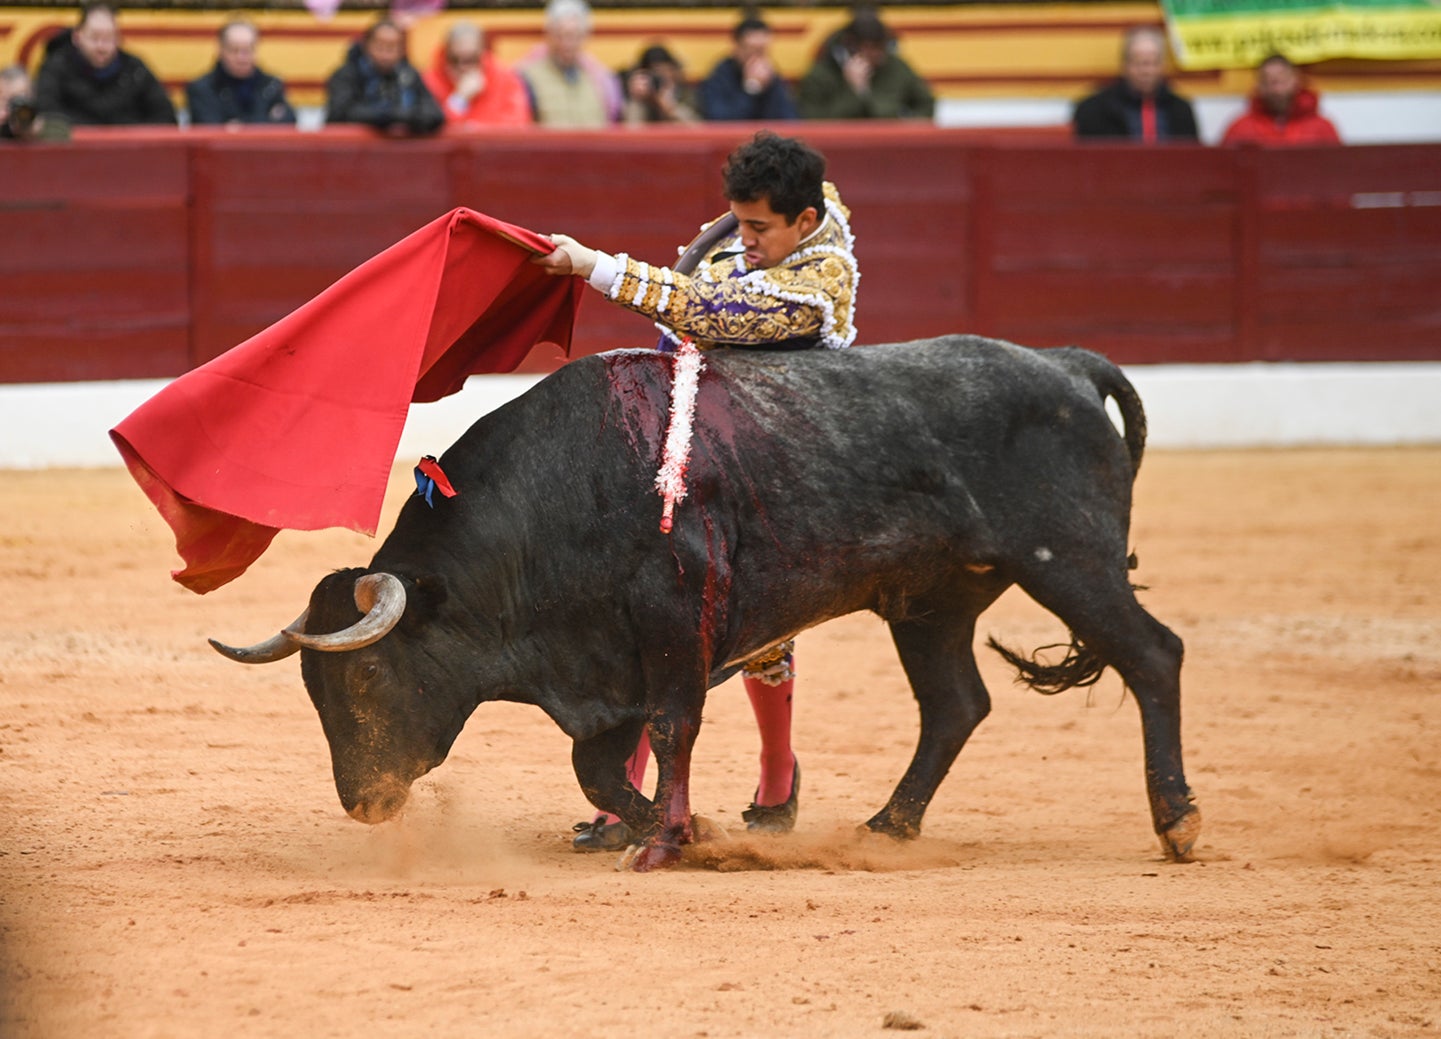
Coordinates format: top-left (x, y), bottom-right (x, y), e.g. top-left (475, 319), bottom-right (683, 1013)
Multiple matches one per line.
top-left (516, 0), bottom-right (621, 127)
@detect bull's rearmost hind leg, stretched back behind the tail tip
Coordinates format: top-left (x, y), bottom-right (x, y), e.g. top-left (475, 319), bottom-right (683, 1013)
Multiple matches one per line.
top-left (1020, 562), bottom-right (1200, 862)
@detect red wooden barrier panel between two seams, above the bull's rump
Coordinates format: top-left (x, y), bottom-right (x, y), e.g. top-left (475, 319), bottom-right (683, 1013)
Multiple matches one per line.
top-left (974, 146), bottom-right (1245, 362)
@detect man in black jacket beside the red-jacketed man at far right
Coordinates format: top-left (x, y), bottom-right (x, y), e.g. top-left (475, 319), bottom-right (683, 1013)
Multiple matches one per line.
top-left (1071, 26), bottom-right (1196, 143)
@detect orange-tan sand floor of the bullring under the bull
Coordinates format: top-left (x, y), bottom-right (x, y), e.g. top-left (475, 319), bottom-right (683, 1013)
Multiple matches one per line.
top-left (0, 450), bottom-right (1441, 1039)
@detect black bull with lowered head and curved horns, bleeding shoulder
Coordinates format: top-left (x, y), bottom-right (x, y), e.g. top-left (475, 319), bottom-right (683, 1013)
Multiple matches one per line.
top-left (216, 336), bottom-right (1200, 869)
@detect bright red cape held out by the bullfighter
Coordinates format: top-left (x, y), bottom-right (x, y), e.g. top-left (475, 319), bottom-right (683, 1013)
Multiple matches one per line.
top-left (110, 209), bottom-right (585, 592)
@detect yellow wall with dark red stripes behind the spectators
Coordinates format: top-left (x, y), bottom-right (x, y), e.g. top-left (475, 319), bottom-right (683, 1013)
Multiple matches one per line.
top-left (0, 3), bottom-right (1441, 105)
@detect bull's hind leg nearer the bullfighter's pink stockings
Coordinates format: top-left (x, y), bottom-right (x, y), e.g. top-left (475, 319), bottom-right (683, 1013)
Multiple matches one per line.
top-left (866, 605), bottom-right (990, 839)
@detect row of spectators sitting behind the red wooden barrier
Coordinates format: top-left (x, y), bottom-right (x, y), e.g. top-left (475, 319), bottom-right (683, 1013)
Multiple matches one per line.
top-left (0, 0), bottom-right (1340, 144)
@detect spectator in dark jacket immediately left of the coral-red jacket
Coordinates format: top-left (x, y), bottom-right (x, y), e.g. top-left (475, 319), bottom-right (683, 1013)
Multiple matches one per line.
top-left (326, 19), bottom-right (445, 137)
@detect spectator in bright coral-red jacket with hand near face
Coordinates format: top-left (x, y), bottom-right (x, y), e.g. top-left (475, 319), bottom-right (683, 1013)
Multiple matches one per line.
top-left (425, 22), bottom-right (532, 127)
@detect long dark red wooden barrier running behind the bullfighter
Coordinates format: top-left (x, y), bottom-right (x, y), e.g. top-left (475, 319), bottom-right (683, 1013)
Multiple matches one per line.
top-left (0, 124), bottom-right (1441, 382)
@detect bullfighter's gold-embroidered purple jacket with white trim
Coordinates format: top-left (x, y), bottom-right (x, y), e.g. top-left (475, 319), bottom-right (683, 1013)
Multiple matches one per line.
top-left (591, 182), bottom-right (860, 350)
